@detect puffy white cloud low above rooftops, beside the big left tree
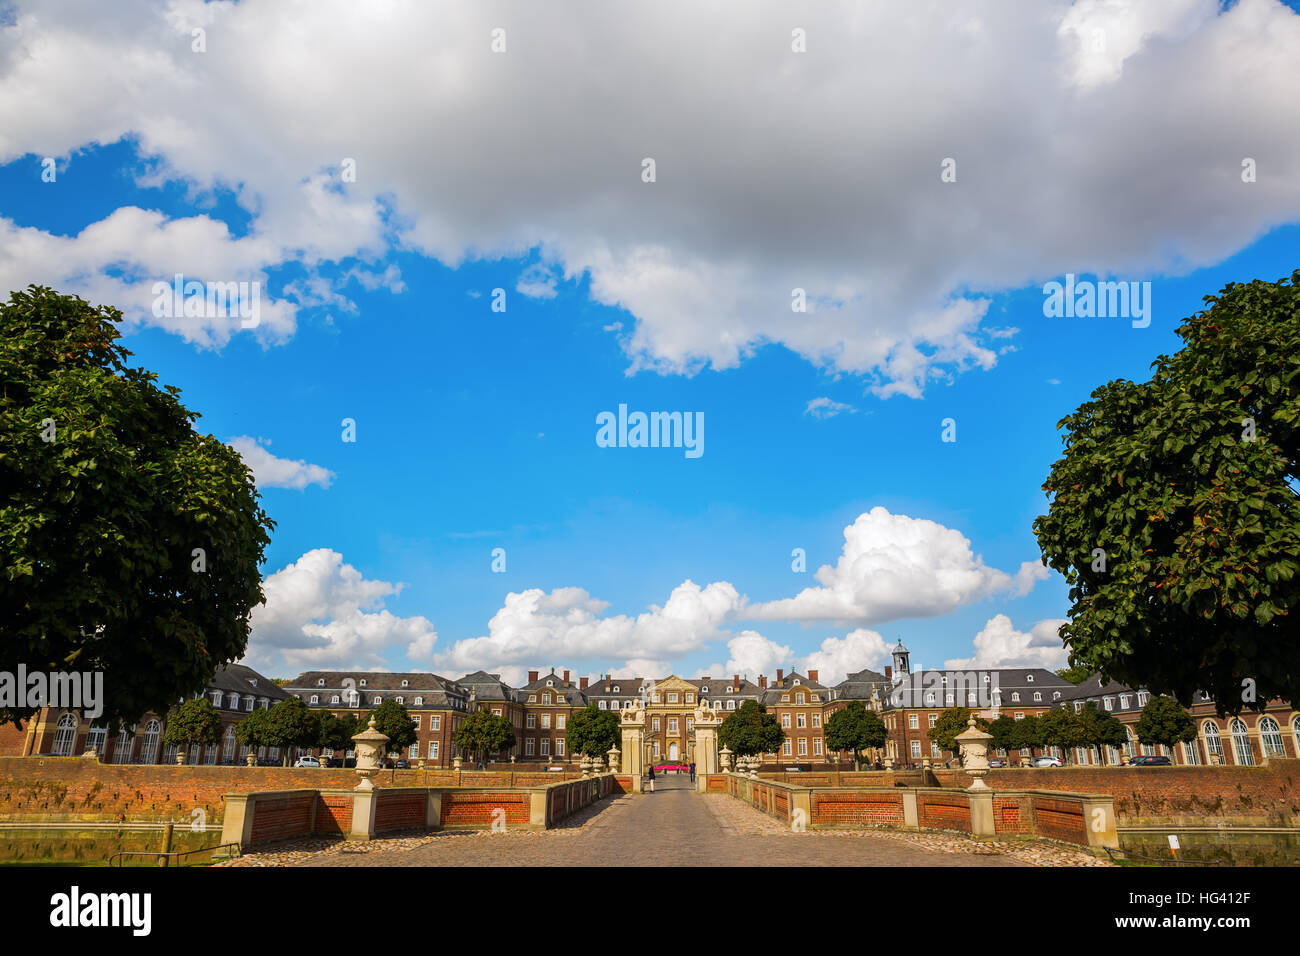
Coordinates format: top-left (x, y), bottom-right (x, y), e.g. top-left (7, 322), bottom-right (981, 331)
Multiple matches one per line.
top-left (244, 548), bottom-right (438, 672)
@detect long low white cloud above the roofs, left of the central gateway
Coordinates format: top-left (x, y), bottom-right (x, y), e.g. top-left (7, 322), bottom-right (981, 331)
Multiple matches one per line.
top-left (437, 580), bottom-right (741, 671)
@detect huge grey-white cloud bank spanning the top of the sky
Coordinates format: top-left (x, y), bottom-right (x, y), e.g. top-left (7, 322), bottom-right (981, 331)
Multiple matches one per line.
top-left (0, 0), bottom-right (1300, 395)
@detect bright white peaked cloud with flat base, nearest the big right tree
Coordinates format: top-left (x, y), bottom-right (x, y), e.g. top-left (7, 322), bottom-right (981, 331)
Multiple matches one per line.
top-left (744, 507), bottom-right (1047, 624)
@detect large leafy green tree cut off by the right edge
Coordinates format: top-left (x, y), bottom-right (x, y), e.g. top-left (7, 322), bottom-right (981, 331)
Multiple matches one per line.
top-left (1034, 271), bottom-right (1300, 714)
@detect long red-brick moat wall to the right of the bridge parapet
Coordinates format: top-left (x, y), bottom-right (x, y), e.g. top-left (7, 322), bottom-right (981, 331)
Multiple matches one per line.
top-left (935, 760), bottom-right (1300, 826)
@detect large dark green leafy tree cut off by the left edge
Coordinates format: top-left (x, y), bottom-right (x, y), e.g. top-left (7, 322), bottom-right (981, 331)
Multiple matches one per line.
top-left (0, 286), bottom-right (274, 726)
